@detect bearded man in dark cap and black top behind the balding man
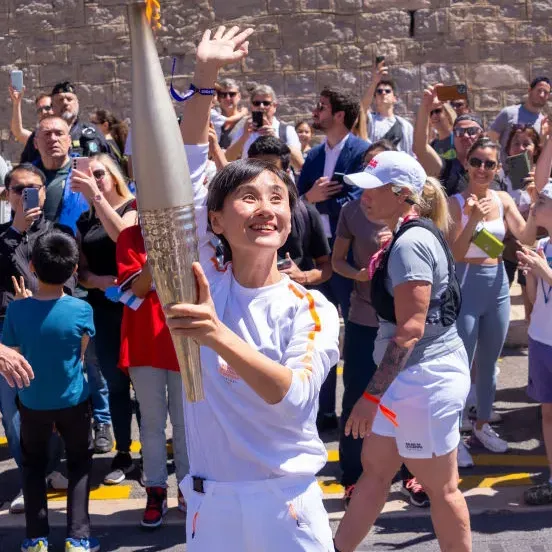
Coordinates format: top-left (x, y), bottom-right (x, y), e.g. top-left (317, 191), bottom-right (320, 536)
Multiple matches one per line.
top-left (20, 81), bottom-right (112, 163)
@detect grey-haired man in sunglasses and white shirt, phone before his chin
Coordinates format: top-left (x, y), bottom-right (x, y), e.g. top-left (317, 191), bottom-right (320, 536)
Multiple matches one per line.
top-left (226, 84), bottom-right (303, 171)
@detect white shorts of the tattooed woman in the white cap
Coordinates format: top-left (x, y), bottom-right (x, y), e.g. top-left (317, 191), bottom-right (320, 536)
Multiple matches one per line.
top-left (372, 347), bottom-right (470, 458)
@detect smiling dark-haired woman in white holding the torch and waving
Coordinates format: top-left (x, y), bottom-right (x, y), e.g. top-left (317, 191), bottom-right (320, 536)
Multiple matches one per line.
top-left (165, 27), bottom-right (339, 552)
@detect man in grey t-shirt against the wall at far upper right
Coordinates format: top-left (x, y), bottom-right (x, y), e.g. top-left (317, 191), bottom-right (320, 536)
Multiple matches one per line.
top-left (488, 76), bottom-right (551, 162)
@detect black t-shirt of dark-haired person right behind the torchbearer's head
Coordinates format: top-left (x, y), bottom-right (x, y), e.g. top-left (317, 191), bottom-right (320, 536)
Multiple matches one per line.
top-left (278, 200), bottom-right (331, 270)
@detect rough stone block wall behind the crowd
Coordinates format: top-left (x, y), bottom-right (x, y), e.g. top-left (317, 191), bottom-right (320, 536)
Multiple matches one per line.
top-left (0, 0), bottom-right (552, 158)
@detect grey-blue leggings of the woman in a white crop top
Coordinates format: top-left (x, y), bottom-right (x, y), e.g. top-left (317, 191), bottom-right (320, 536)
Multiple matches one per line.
top-left (456, 263), bottom-right (510, 420)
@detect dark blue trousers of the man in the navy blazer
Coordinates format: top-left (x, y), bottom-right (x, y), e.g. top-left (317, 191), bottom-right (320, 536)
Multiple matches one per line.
top-left (317, 272), bottom-right (353, 415)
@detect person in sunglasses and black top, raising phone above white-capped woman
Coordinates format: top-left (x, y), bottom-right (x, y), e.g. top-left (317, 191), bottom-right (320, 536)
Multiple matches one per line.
top-left (414, 84), bottom-right (502, 196)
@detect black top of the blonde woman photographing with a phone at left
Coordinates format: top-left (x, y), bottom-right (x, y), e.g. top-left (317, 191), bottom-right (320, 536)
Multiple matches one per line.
top-left (77, 199), bottom-right (134, 307)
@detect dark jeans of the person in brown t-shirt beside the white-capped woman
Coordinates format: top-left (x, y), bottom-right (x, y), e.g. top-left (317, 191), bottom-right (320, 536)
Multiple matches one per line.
top-left (339, 320), bottom-right (378, 487)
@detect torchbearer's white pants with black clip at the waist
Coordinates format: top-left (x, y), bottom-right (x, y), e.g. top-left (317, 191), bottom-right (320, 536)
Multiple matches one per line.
top-left (180, 475), bottom-right (334, 552)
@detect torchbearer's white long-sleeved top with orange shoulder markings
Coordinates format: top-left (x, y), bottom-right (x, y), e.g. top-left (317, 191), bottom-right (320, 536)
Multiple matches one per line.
top-left (184, 145), bottom-right (339, 481)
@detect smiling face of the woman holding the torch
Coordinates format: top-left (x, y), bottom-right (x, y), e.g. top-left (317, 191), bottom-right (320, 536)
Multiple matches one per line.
top-left (209, 171), bottom-right (291, 258)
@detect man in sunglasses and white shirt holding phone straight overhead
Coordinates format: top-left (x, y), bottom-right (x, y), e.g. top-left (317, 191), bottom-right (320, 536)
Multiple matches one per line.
top-left (361, 60), bottom-right (414, 155)
